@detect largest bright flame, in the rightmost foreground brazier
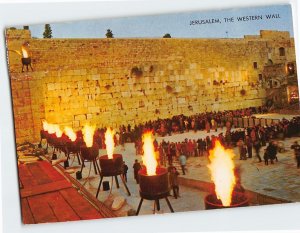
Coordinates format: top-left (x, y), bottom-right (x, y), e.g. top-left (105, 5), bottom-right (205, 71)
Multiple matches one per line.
top-left (208, 141), bottom-right (236, 206)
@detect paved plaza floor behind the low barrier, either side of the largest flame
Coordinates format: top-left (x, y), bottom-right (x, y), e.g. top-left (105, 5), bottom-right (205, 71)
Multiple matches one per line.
top-left (177, 137), bottom-right (300, 202)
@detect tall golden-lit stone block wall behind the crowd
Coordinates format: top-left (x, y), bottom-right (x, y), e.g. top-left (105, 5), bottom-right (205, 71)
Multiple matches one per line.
top-left (6, 30), bottom-right (295, 142)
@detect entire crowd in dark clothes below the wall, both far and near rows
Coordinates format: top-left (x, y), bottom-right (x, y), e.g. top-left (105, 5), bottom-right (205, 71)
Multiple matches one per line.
top-left (67, 107), bottom-right (300, 181)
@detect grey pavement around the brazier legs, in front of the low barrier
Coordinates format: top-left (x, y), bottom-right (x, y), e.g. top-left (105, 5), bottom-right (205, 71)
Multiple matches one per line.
top-left (60, 143), bottom-right (207, 216)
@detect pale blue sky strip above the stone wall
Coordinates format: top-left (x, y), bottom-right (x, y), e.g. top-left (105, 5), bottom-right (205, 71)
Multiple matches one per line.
top-left (14, 5), bottom-right (293, 38)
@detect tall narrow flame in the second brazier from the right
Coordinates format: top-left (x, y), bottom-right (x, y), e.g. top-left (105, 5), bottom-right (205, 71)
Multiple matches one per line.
top-left (143, 132), bottom-right (157, 176)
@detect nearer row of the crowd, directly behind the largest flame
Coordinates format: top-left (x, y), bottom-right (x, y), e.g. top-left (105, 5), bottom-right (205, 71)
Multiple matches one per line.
top-left (154, 117), bottom-right (300, 166)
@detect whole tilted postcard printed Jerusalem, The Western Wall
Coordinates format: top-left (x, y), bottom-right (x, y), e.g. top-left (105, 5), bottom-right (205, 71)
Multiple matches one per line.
top-left (5, 5), bottom-right (300, 224)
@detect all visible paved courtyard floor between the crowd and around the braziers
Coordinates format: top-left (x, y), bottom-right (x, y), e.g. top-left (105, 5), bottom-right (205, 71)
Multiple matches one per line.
top-left (48, 114), bottom-right (300, 216)
